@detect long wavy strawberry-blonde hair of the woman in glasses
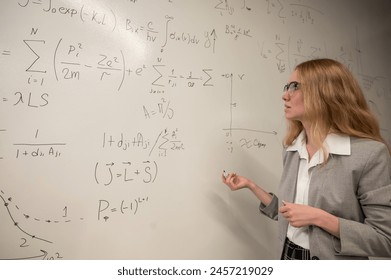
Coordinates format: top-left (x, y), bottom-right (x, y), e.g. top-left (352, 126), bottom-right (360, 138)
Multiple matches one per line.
top-left (284, 59), bottom-right (391, 159)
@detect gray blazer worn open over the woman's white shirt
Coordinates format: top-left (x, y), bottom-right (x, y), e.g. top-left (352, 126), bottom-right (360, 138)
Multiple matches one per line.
top-left (259, 137), bottom-right (391, 259)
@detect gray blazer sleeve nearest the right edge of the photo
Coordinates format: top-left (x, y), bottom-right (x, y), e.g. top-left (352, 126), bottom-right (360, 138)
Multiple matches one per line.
top-left (334, 142), bottom-right (391, 257)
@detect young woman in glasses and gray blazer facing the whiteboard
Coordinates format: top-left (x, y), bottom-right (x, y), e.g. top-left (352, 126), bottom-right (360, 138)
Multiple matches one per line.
top-left (222, 59), bottom-right (391, 259)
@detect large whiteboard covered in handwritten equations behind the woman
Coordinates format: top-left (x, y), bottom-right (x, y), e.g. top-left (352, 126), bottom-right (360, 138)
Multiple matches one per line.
top-left (0, 0), bottom-right (391, 259)
